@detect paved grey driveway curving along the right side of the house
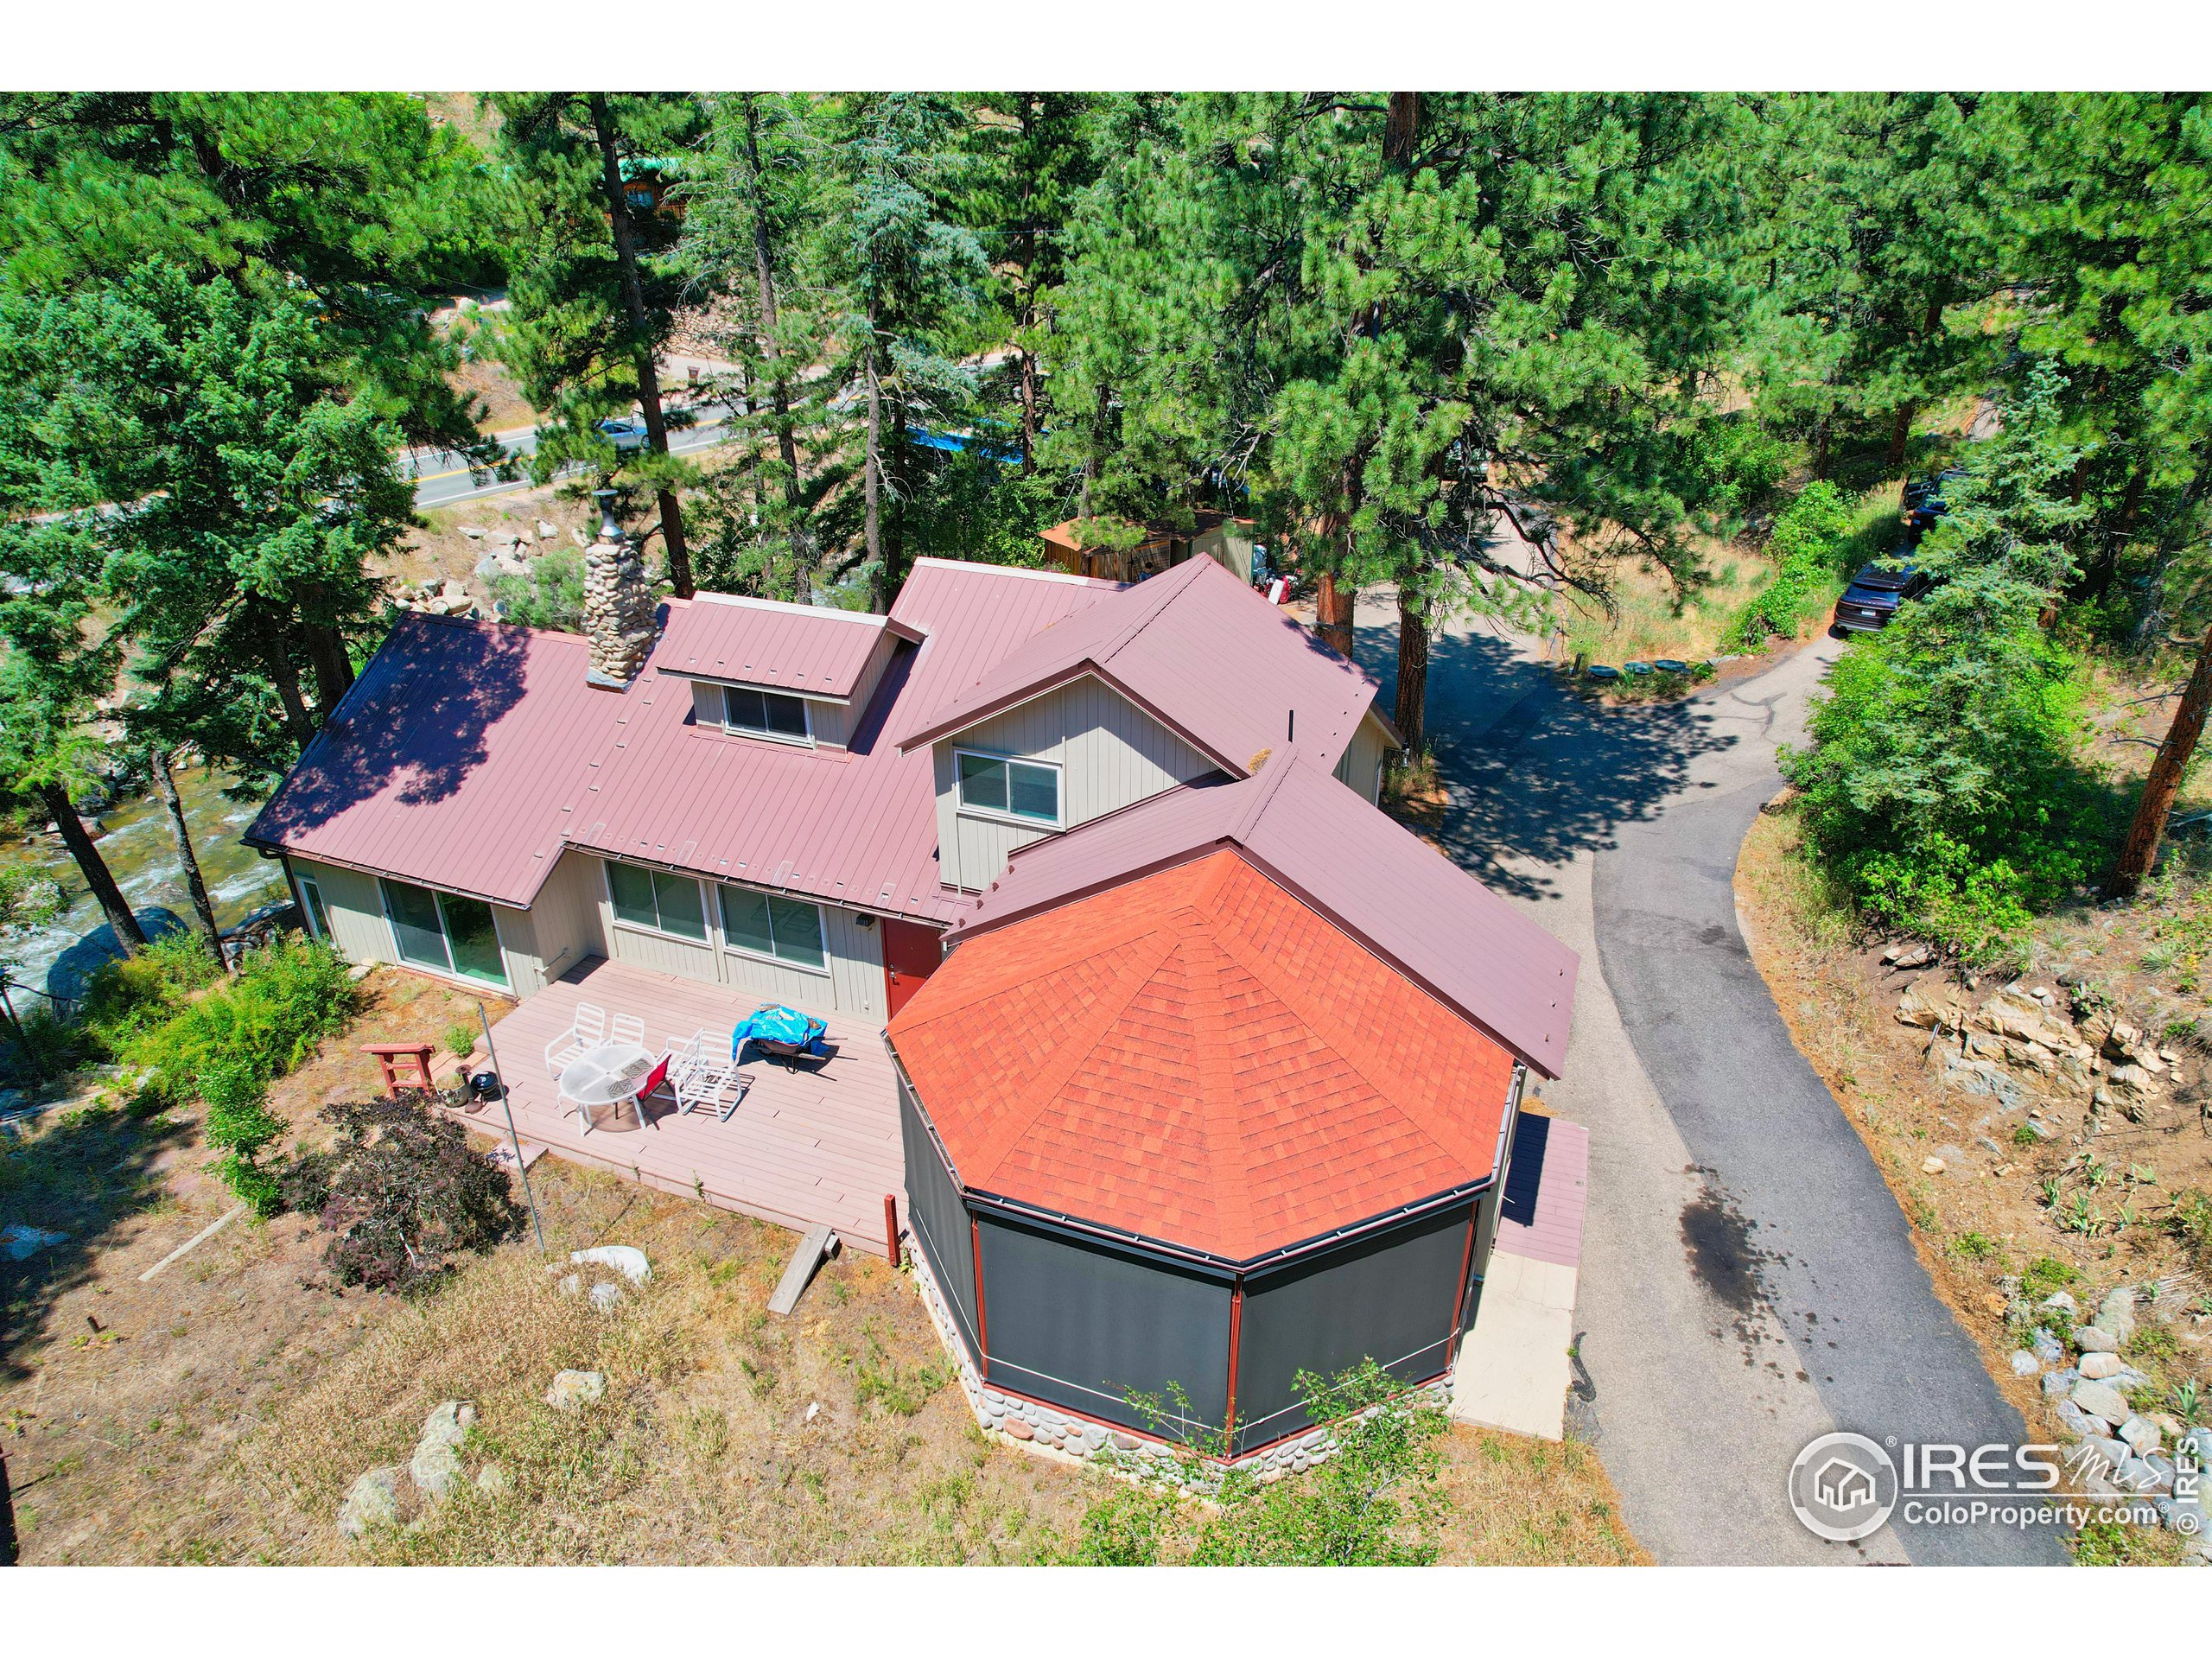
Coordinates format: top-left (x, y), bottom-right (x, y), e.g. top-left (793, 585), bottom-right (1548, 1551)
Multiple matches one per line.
top-left (1360, 595), bottom-right (2066, 1564)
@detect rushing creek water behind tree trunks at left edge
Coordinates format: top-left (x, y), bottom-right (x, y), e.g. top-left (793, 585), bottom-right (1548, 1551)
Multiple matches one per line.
top-left (0, 767), bottom-right (288, 991)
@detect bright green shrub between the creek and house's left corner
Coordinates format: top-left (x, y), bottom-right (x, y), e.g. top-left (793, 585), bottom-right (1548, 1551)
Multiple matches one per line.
top-left (118, 938), bottom-right (356, 1099)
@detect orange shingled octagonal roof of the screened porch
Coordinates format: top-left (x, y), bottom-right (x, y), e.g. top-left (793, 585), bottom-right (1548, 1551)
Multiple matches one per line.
top-left (889, 858), bottom-right (1513, 1261)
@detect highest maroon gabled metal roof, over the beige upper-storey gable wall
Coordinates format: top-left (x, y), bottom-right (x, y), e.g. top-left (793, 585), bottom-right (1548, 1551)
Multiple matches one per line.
top-left (898, 557), bottom-right (1376, 777)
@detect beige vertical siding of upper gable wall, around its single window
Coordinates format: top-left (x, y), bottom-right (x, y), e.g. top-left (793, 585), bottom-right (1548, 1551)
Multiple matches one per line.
top-left (936, 675), bottom-right (1217, 892)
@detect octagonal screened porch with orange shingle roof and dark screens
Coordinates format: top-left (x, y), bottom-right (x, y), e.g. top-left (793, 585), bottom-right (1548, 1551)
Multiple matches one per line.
top-left (889, 845), bottom-right (1524, 1460)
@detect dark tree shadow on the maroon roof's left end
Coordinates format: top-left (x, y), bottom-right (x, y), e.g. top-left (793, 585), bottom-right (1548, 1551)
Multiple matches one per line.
top-left (252, 617), bottom-right (535, 838)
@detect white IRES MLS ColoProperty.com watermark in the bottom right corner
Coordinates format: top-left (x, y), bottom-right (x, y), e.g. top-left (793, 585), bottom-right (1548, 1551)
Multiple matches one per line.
top-left (1789, 1431), bottom-right (2203, 1544)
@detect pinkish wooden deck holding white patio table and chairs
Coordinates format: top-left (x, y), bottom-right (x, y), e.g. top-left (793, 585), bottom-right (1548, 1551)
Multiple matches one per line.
top-left (467, 956), bottom-right (907, 1255)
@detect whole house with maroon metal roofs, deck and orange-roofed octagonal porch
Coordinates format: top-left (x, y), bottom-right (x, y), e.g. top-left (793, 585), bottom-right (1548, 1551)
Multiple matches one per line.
top-left (248, 506), bottom-right (1575, 1458)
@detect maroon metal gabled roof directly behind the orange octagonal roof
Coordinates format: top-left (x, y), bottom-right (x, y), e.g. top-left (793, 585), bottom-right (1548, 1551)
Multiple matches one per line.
top-left (951, 746), bottom-right (1580, 1077)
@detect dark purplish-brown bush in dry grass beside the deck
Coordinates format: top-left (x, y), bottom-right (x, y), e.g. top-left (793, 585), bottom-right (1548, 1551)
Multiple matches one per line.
top-left (283, 1090), bottom-right (522, 1294)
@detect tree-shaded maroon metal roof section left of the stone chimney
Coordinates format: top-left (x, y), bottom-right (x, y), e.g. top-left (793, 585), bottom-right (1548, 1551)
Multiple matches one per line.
top-left (245, 613), bottom-right (613, 905)
